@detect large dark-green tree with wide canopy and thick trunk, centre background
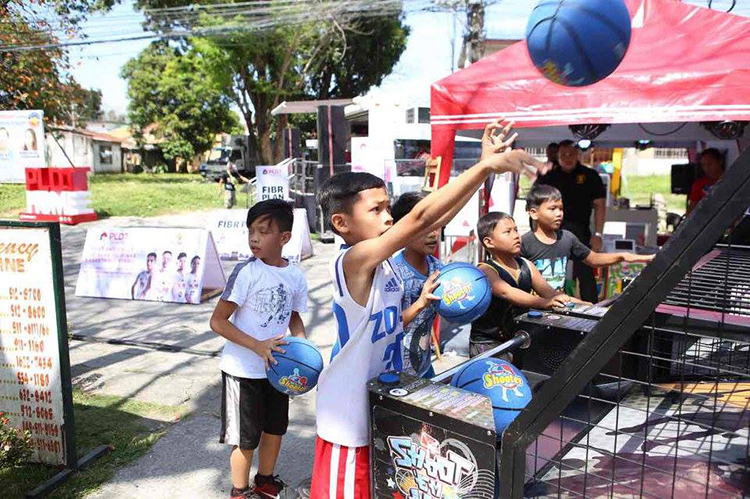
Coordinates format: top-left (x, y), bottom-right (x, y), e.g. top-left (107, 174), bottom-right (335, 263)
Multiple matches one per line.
top-left (132, 0), bottom-right (409, 164)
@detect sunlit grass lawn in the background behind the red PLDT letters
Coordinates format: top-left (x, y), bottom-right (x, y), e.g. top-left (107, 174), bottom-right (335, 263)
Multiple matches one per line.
top-left (0, 173), bottom-right (254, 218)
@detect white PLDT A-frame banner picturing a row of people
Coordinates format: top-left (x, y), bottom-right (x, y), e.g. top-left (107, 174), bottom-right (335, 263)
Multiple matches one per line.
top-left (76, 227), bottom-right (226, 305)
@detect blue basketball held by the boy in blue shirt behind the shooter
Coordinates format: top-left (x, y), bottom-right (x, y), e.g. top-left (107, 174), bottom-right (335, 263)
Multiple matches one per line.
top-left (434, 262), bottom-right (492, 324)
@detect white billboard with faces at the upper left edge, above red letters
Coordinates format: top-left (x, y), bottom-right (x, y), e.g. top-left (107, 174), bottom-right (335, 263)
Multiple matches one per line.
top-left (0, 110), bottom-right (47, 184)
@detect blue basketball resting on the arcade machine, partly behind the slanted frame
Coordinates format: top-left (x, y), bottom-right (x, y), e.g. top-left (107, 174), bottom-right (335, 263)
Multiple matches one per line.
top-left (451, 358), bottom-right (531, 438)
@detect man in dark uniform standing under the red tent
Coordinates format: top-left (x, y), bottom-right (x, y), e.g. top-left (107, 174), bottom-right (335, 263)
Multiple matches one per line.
top-left (537, 140), bottom-right (607, 303)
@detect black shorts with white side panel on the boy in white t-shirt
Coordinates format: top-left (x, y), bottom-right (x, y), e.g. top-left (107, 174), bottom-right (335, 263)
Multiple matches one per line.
top-left (219, 372), bottom-right (289, 450)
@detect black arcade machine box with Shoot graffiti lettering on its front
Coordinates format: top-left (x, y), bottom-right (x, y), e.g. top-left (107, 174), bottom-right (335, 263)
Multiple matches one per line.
top-left (367, 373), bottom-right (497, 499)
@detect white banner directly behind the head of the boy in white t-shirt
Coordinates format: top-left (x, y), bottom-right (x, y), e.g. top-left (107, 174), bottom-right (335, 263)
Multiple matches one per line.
top-left (206, 208), bottom-right (313, 263)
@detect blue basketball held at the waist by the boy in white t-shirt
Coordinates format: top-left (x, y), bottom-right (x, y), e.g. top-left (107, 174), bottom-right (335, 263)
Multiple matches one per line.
top-left (266, 336), bottom-right (323, 397)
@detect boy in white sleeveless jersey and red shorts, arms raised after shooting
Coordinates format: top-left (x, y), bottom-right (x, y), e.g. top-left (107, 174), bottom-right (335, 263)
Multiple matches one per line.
top-left (310, 122), bottom-right (547, 499)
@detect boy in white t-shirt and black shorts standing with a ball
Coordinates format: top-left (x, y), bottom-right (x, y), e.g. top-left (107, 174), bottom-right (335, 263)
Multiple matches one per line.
top-left (211, 199), bottom-right (307, 499)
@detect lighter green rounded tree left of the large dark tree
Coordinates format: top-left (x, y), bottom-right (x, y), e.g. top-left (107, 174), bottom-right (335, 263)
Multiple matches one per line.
top-left (122, 42), bottom-right (238, 170)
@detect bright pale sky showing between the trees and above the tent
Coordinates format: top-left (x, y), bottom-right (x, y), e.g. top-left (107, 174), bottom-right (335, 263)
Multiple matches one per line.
top-left (70, 0), bottom-right (750, 113)
